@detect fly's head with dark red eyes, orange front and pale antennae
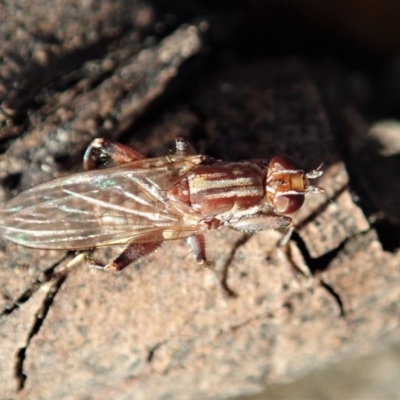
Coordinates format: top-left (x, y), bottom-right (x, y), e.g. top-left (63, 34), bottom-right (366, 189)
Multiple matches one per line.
top-left (266, 155), bottom-right (324, 214)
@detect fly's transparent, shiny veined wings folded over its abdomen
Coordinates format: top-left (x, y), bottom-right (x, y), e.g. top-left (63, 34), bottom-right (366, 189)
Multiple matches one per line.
top-left (0, 156), bottom-right (201, 249)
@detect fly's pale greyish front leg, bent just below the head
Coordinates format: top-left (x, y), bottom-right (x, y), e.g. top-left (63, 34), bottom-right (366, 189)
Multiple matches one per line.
top-left (232, 213), bottom-right (294, 247)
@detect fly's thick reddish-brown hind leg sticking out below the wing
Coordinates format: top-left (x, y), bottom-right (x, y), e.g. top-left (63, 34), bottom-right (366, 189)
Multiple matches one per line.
top-left (87, 241), bottom-right (162, 271)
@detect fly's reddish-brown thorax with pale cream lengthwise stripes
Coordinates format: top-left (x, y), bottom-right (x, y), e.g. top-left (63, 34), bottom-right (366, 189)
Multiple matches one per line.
top-left (168, 161), bottom-right (265, 218)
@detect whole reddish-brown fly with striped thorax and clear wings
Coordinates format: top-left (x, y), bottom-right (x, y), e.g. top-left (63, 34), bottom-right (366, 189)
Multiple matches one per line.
top-left (0, 138), bottom-right (323, 271)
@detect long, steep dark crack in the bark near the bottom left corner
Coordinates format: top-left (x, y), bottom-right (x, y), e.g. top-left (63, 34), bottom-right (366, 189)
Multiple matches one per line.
top-left (15, 276), bottom-right (66, 391)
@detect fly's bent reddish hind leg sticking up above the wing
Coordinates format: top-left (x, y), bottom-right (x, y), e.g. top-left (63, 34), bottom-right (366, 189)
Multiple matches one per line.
top-left (83, 138), bottom-right (146, 171)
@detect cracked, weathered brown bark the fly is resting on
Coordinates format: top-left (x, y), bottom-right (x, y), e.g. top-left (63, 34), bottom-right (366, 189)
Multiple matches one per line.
top-left (0, 2), bottom-right (400, 399)
